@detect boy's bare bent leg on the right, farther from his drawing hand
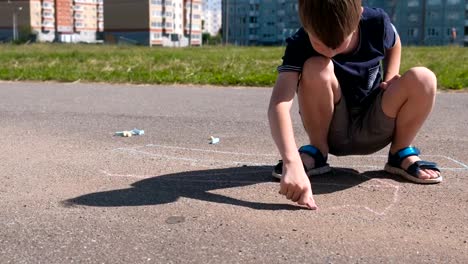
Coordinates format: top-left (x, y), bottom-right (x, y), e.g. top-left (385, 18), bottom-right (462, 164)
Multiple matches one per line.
top-left (382, 67), bottom-right (439, 179)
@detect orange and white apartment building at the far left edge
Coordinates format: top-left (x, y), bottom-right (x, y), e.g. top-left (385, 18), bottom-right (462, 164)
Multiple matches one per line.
top-left (0, 0), bottom-right (104, 42)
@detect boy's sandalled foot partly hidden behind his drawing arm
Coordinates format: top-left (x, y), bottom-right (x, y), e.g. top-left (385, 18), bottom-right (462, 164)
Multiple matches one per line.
top-left (272, 145), bottom-right (331, 179)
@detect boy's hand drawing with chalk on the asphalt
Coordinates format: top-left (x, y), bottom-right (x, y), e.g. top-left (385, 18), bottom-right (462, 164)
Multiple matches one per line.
top-left (279, 162), bottom-right (317, 210)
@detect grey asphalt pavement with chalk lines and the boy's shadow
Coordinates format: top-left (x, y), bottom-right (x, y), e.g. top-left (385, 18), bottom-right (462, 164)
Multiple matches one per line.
top-left (0, 82), bottom-right (468, 263)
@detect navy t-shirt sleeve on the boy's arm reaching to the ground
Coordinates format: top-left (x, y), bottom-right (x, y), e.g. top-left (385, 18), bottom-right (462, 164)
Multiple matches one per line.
top-left (277, 28), bottom-right (310, 72)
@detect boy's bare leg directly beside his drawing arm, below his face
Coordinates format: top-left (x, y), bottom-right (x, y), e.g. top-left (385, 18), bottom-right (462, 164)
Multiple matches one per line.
top-left (298, 56), bottom-right (341, 165)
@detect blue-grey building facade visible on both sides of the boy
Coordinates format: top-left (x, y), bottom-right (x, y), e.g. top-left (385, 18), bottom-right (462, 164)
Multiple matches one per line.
top-left (222, 0), bottom-right (468, 46)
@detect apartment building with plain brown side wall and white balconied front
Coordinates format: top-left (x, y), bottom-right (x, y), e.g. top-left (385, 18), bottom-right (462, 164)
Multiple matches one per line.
top-left (104, 0), bottom-right (202, 47)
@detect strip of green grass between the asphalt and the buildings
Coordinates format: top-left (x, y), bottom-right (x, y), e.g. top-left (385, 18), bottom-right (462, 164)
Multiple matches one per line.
top-left (0, 44), bottom-right (468, 89)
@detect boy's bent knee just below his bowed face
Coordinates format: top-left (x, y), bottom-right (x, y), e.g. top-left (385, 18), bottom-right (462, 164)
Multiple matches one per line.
top-left (301, 56), bottom-right (335, 82)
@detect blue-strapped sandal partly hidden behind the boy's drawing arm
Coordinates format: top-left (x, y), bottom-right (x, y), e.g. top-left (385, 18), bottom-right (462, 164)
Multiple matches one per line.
top-left (272, 145), bottom-right (331, 179)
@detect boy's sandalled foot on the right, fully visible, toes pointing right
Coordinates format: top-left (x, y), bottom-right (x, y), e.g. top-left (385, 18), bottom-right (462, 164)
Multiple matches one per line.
top-left (384, 147), bottom-right (442, 184)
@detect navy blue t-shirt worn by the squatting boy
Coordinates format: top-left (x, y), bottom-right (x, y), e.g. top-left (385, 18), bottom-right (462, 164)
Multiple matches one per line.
top-left (278, 7), bottom-right (396, 106)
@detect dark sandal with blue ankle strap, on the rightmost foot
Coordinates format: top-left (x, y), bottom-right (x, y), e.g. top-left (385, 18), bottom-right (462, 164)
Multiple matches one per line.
top-left (384, 147), bottom-right (442, 183)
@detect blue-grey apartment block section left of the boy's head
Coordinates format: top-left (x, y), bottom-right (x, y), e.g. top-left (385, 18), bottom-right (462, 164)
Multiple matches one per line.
top-left (222, 0), bottom-right (300, 45)
